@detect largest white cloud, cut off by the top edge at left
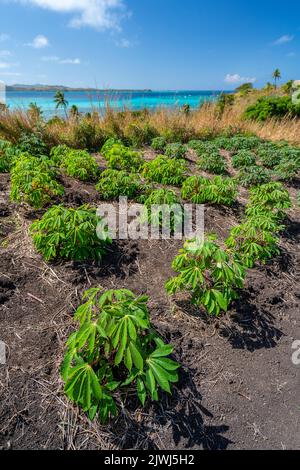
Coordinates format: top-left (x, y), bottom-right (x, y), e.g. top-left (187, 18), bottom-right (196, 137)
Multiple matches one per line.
top-left (11, 0), bottom-right (127, 30)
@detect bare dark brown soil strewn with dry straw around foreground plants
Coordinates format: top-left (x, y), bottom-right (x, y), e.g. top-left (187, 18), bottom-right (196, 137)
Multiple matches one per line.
top-left (0, 156), bottom-right (300, 449)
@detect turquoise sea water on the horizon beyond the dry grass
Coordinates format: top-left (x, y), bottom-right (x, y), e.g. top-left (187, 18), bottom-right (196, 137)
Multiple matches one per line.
top-left (6, 90), bottom-right (221, 115)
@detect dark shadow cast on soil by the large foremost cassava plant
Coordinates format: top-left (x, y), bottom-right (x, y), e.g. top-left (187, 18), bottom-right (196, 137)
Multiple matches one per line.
top-left (113, 370), bottom-right (232, 450)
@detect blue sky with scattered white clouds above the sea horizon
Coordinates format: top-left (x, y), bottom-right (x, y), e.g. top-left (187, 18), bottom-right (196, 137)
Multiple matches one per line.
top-left (0, 0), bottom-right (300, 90)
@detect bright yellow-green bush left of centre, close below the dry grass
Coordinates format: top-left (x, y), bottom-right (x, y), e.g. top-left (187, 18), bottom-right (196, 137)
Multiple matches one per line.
top-left (104, 144), bottom-right (144, 173)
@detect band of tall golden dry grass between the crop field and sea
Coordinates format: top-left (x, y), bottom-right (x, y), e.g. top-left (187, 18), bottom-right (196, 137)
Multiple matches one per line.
top-left (0, 91), bottom-right (300, 149)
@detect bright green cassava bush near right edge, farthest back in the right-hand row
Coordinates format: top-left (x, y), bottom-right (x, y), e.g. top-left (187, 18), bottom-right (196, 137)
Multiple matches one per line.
top-left (246, 182), bottom-right (292, 220)
